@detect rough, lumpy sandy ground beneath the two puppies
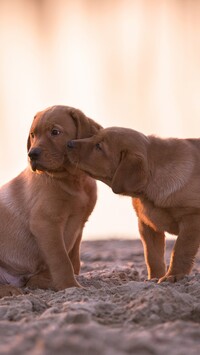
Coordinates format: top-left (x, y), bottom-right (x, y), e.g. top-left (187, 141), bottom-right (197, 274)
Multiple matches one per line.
top-left (0, 240), bottom-right (200, 355)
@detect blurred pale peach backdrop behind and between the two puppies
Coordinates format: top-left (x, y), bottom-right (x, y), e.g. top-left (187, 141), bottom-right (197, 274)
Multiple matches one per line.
top-left (0, 0), bottom-right (200, 239)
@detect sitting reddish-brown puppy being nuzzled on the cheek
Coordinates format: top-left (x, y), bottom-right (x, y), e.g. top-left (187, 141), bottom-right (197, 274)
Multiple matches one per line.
top-left (0, 106), bottom-right (101, 297)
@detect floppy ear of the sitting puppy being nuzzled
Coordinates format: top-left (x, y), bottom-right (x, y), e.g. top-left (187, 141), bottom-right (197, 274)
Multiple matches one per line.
top-left (69, 108), bottom-right (103, 139)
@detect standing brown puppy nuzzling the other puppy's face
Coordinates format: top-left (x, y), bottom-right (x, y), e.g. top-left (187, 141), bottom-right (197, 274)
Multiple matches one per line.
top-left (68, 127), bottom-right (200, 282)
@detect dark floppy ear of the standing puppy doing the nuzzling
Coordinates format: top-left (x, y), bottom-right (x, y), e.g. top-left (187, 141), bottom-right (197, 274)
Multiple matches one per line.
top-left (111, 152), bottom-right (147, 196)
